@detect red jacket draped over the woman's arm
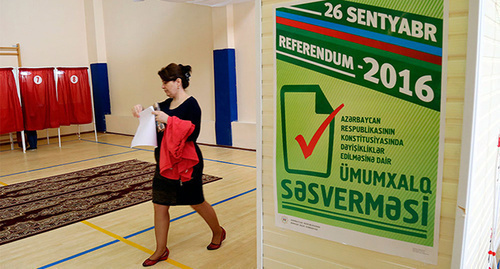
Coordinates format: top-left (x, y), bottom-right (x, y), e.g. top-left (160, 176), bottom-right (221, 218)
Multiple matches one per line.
top-left (159, 116), bottom-right (199, 182)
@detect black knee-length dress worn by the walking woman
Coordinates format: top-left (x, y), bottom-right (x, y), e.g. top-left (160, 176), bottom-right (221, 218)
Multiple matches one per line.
top-left (153, 96), bottom-right (205, 205)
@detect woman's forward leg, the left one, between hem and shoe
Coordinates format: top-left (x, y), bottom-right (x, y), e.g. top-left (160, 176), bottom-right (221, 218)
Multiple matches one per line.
top-left (149, 204), bottom-right (170, 260)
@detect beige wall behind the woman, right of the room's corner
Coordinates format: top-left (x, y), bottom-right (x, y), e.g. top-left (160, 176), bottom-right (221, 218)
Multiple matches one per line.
top-left (103, 0), bottom-right (256, 149)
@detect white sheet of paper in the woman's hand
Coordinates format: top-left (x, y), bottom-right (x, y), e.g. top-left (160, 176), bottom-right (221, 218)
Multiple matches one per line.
top-left (130, 106), bottom-right (158, 148)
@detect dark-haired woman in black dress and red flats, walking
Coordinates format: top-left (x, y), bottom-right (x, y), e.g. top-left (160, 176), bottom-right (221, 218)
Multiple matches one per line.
top-left (132, 63), bottom-right (226, 266)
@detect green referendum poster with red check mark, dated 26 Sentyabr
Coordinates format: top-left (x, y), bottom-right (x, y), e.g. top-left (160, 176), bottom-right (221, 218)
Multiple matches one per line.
top-left (274, 0), bottom-right (446, 264)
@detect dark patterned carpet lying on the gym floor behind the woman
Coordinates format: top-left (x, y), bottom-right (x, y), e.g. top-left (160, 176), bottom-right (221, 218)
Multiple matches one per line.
top-left (0, 160), bottom-right (221, 245)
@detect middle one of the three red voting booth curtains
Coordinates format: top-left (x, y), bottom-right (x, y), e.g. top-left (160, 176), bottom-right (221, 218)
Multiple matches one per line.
top-left (19, 68), bottom-right (60, 131)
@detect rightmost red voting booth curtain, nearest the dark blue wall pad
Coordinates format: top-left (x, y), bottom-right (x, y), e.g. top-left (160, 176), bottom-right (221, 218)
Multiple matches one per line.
top-left (57, 67), bottom-right (92, 125)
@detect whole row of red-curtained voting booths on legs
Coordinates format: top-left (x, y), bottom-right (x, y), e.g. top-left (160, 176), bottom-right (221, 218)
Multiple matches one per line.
top-left (0, 67), bottom-right (97, 151)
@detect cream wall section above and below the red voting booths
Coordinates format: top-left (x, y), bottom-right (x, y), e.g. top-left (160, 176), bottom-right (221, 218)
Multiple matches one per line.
top-left (0, 0), bottom-right (93, 136)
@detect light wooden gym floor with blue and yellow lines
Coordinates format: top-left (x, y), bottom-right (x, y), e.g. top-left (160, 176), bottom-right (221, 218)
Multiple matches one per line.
top-left (0, 133), bottom-right (256, 269)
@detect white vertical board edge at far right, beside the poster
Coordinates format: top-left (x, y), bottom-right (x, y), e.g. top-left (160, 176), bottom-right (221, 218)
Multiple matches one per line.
top-left (455, 0), bottom-right (500, 268)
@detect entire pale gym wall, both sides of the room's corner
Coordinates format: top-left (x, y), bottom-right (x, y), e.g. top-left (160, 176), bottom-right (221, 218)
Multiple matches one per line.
top-left (0, 0), bottom-right (256, 149)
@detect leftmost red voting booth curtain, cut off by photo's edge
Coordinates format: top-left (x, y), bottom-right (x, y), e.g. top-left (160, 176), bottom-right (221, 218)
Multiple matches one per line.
top-left (0, 68), bottom-right (24, 134)
